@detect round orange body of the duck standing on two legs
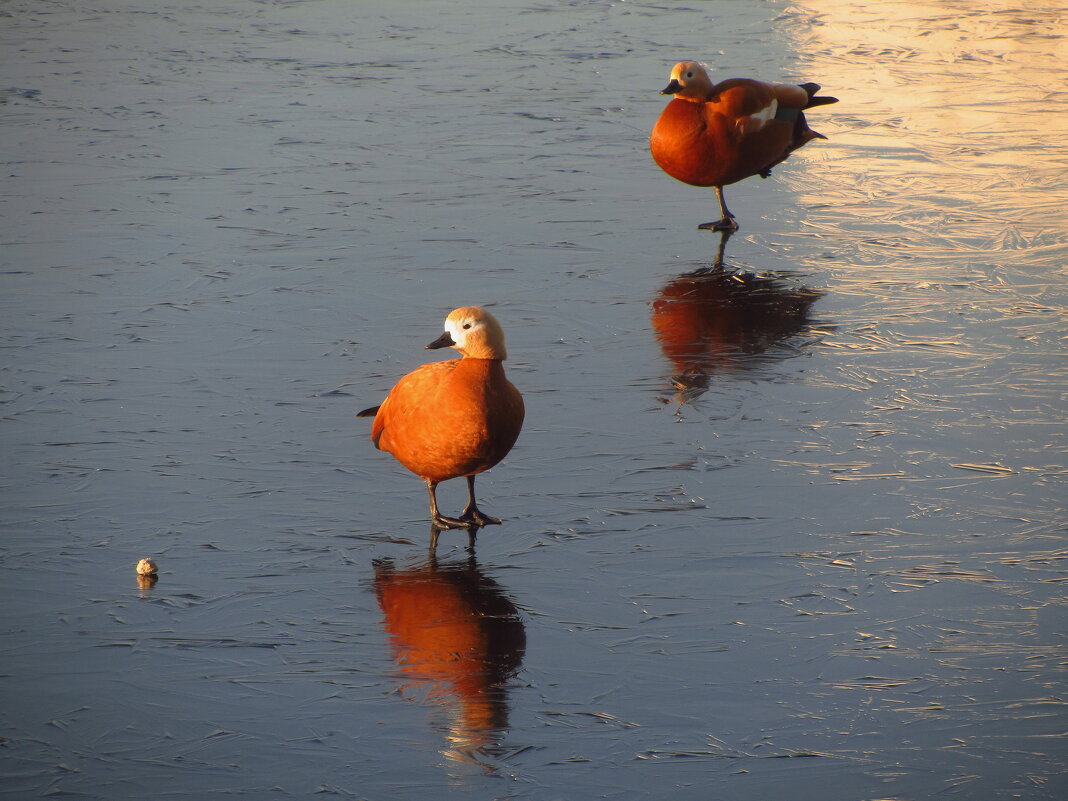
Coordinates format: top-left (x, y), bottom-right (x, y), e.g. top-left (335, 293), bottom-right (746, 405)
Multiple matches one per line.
top-left (371, 358), bottom-right (523, 482)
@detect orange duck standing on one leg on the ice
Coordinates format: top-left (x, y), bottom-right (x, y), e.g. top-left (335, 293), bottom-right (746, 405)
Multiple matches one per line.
top-left (649, 61), bottom-right (838, 231)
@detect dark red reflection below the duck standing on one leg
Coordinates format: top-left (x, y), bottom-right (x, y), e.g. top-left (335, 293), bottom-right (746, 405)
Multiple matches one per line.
top-left (653, 234), bottom-right (822, 403)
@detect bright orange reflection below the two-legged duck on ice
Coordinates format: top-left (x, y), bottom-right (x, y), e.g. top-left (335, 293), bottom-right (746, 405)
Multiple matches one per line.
top-left (374, 553), bottom-right (527, 767)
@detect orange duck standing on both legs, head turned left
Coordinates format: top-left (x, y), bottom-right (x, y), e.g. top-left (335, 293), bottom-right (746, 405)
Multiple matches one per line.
top-left (357, 307), bottom-right (525, 539)
